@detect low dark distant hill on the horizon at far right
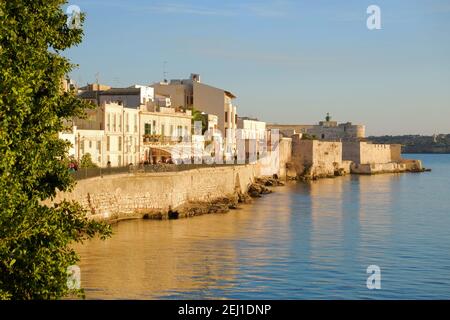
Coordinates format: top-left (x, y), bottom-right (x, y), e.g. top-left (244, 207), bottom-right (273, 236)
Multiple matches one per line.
top-left (367, 134), bottom-right (450, 153)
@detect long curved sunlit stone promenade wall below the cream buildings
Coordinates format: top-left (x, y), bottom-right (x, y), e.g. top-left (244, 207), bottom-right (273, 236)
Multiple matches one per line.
top-left (51, 164), bottom-right (259, 218)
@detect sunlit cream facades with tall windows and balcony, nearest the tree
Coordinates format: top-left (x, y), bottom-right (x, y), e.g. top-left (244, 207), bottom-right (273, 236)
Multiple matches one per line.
top-left (67, 100), bottom-right (192, 167)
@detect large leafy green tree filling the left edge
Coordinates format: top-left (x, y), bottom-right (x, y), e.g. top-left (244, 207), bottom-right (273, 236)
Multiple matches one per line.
top-left (0, 0), bottom-right (110, 299)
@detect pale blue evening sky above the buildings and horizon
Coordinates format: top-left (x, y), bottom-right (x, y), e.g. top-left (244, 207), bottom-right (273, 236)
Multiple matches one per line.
top-left (64, 0), bottom-right (450, 135)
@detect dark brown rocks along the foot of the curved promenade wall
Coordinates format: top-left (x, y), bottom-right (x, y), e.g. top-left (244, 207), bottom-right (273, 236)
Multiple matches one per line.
top-left (107, 175), bottom-right (284, 223)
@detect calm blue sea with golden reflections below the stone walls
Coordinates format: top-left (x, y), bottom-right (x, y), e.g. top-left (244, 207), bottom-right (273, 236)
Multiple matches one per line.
top-left (78, 155), bottom-right (450, 299)
